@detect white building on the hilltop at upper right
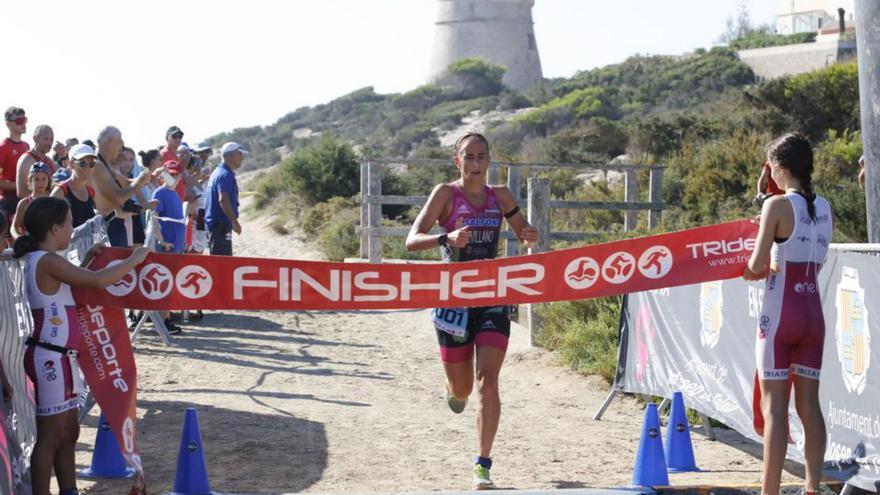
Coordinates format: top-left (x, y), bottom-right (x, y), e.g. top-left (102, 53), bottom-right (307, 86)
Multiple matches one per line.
top-left (776, 0), bottom-right (855, 34)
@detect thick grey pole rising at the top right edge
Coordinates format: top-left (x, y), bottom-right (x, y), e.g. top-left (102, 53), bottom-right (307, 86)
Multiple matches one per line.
top-left (855, 0), bottom-right (880, 242)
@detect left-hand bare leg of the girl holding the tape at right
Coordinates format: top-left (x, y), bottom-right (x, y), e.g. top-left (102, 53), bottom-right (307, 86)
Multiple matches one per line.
top-left (761, 380), bottom-right (789, 495)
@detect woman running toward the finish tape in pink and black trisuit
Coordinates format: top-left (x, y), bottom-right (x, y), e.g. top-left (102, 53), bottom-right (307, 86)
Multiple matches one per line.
top-left (406, 132), bottom-right (538, 489)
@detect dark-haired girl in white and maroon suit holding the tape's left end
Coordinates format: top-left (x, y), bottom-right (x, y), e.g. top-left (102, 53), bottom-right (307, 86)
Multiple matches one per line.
top-left (13, 197), bottom-right (149, 495)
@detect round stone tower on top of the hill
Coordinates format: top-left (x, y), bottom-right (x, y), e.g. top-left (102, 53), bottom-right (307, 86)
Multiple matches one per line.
top-left (428, 0), bottom-right (543, 91)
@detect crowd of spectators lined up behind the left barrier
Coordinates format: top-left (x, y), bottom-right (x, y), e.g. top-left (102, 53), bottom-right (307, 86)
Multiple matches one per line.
top-left (0, 106), bottom-right (247, 334)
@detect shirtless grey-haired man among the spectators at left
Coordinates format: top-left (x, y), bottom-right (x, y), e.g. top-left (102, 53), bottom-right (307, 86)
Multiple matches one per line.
top-left (90, 126), bottom-right (150, 247)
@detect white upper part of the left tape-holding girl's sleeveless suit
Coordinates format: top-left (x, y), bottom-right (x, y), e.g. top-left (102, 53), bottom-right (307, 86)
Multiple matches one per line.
top-left (25, 251), bottom-right (81, 349)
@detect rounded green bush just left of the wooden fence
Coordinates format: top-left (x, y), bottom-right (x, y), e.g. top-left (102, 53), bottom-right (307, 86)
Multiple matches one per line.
top-left (280, 136), bottom-right (360, 204)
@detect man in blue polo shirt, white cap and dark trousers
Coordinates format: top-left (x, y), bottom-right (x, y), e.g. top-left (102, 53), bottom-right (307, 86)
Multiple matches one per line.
top-left (205, 142), bottom-right (247, 256)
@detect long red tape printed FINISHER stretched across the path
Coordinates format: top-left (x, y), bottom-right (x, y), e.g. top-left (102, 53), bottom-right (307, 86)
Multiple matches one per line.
top-left (74, 220), bottom-right (758, 310)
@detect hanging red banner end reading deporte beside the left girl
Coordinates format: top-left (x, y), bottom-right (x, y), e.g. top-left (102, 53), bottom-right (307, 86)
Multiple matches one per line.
top-left (75, 258), bottom-right (146, 494)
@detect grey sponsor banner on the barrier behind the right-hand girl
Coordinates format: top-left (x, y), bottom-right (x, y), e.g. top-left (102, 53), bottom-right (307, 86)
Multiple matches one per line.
top-left (617, 251), bottom-right (880, 491)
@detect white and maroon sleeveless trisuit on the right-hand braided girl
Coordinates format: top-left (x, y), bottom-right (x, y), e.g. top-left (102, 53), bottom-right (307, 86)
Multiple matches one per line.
top-left (756, 192), bottom-right (832, 380)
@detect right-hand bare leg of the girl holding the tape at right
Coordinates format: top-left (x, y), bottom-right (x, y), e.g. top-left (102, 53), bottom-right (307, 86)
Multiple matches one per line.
top-left (794, 376), bottom-right (826, 491)
